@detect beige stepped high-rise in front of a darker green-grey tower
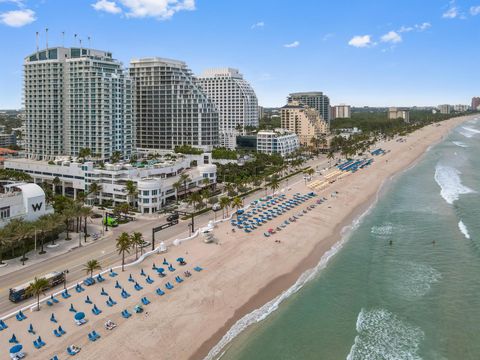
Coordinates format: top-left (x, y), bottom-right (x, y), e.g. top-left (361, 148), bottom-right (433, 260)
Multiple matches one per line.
top-left (281, 101), bottom-right (329, 146)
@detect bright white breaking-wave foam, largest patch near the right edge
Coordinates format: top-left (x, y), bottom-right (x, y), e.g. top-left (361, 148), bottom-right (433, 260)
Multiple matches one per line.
top-left (435, 164), bottom-right (475, 204)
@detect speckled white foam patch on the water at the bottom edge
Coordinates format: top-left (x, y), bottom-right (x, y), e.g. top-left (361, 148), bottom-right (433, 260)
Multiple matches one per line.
top-left (347, 309), bottom-right (425, 360)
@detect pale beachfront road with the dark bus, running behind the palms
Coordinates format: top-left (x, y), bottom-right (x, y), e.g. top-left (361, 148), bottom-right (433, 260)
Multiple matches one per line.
top-left (0, 159), bottom-right (327, 314)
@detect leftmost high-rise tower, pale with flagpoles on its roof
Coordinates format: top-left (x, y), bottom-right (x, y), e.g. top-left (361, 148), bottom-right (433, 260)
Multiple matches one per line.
top-left (24, 47), bottom-right (132, 160)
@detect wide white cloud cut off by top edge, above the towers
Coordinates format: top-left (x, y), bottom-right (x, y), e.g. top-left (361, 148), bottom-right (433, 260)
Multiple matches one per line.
top-left (92, 0), bottom-right (195, 20)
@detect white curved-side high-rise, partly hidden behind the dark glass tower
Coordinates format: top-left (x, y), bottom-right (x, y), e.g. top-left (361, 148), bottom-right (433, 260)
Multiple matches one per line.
top-left (198, 68), bottom-right (258, 148)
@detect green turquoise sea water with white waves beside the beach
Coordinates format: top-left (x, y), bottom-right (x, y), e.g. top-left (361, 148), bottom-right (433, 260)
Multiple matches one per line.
top-left (218, 121), bottom-right (480, 360)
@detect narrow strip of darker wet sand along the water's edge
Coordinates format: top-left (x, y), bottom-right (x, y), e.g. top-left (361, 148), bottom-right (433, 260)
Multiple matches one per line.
top-left (189, 116), bottom-right (471, 360)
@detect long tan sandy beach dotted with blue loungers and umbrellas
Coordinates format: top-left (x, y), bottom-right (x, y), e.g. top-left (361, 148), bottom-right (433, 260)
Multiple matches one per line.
top-left (0, 117), bottom-right (469, 360)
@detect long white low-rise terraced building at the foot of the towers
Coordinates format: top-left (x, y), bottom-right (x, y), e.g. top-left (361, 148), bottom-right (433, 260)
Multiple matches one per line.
top-left (5, 153), bottom-right (217, 214)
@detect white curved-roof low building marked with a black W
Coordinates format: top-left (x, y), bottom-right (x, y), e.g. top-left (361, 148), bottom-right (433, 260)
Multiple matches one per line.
top-left (0, 183), bottom-right (53, 227)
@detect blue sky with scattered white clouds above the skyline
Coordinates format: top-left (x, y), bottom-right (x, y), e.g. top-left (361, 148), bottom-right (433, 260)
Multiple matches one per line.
top-left (0, 0), bottom-right (480, 109)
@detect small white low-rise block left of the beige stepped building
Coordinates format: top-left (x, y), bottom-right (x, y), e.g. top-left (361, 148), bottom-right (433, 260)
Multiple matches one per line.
top-left (257, 129), bottom-right (300, 156)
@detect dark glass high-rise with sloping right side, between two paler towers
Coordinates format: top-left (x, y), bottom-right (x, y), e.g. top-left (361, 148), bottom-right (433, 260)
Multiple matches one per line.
top-left (130, 57), bottom-right (219, 151)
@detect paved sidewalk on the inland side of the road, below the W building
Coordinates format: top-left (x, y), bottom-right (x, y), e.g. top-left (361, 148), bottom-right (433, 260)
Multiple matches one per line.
top-left (0, 224), bottom-right (112, 276)
